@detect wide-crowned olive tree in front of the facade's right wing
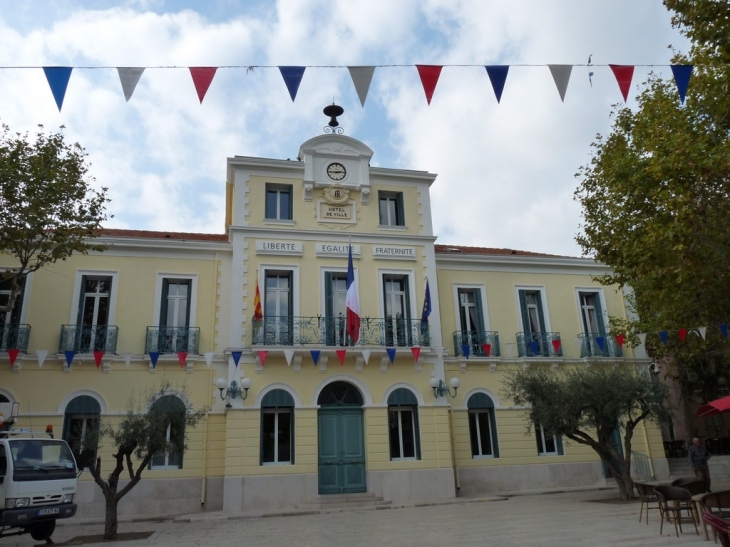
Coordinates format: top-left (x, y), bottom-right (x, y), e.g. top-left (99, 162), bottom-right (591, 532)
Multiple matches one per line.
top-left (503, 364), bottom-right (669, 500)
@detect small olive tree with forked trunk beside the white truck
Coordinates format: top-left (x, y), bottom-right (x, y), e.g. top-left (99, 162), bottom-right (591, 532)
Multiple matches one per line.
top-left (84, 381), bottom-right (207, 539)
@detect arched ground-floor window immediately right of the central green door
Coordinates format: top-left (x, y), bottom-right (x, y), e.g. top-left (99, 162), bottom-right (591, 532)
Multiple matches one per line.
top-left (388, 388), bottom-right (421, 461)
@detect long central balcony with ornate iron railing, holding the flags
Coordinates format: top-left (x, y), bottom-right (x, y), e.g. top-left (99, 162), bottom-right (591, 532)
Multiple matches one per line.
top-left (251, 316), bottom-right (431, 347)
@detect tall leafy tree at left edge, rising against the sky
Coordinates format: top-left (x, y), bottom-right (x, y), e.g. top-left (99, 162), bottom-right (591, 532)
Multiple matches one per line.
top-left (0, 124), bottom-right (109, 312)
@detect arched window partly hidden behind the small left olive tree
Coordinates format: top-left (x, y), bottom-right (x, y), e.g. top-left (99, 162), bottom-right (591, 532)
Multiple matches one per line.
top-left (149, 395), bottom-right (185, 469)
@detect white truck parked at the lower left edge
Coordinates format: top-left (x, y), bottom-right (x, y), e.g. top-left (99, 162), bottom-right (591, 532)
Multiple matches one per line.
top-left (0, 403), bottom-right (77, 543)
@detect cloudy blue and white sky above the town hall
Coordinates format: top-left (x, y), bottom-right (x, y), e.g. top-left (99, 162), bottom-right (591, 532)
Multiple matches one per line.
top-left (0, 0), bottom-right (691, 256)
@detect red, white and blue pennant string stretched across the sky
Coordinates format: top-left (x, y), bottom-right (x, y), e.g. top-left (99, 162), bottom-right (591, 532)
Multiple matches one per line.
top-left (9, 62), bottom-right (694, 112)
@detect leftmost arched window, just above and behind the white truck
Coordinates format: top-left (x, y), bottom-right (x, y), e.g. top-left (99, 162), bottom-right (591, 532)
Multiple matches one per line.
top-left (63, 395), bottom-right (101, 469)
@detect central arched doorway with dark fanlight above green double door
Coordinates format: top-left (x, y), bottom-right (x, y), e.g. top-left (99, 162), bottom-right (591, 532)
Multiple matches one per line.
top-left (317, 382), bottom-right (366, 494)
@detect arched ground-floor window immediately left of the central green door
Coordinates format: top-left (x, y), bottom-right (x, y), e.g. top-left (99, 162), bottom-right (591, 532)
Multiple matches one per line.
top-left (261, 389), bottom-right (294, 465)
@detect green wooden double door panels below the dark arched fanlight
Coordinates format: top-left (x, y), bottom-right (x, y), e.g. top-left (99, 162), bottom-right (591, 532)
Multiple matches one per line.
top-left (318, 407), bottom-right (366, 494)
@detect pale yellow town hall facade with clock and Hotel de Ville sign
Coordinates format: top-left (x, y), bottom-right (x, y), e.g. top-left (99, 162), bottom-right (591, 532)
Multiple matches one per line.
top-left (0, 127), bottom-right (666, 516)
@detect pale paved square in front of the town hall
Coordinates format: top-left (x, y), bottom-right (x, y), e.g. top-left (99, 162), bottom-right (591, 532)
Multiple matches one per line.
top-left (0, 485), bottom-right (719, 547)
